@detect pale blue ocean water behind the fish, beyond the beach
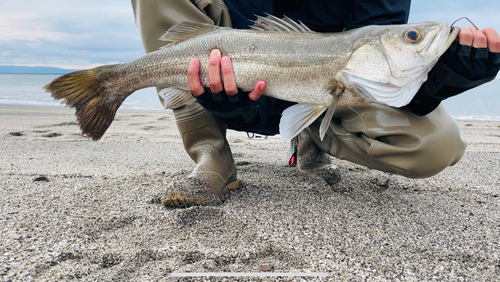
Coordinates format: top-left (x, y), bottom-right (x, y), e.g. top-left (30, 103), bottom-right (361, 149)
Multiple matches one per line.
top-left (0, 74), bottom-right (500, 121)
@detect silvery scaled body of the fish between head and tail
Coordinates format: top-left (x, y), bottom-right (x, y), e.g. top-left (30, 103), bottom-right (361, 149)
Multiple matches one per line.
top-left (105, 29), bottom-right (370, 106)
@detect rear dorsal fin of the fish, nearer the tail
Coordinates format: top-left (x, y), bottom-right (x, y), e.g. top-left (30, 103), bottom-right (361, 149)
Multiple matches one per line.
top-left (159, 22), bottom-right (222, 44)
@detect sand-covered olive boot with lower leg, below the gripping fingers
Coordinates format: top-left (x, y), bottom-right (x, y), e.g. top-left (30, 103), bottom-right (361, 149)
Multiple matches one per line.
top-left (162, 103), bottom-right (239, 207)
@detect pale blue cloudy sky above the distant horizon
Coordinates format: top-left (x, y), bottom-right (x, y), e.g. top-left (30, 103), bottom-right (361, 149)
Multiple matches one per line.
top-left (0, 0), bottom-right (500, 69)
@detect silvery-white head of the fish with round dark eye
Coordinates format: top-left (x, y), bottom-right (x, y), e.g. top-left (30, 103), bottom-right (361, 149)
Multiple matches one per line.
top-left (342, 22), bottom-right (459, 107)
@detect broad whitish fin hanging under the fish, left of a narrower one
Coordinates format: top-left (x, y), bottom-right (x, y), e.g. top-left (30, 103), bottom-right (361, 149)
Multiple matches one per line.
top-left (280, 104), bottom-right (326, 141)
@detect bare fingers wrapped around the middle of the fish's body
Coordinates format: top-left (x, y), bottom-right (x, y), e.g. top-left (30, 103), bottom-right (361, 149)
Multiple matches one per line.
top-left (188, 49), bottom-right (266, 101)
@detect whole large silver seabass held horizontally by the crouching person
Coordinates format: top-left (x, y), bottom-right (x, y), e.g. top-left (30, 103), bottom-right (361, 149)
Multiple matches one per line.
top-left (45, 16), bottom-right (459, 140)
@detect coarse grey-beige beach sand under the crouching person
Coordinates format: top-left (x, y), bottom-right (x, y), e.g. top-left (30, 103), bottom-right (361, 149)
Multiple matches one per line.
top-left (0, 106), bottom-right (500, 281)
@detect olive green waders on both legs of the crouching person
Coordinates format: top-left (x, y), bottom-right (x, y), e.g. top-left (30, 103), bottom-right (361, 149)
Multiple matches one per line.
top-left (132, 0), bottom-right (466, 206)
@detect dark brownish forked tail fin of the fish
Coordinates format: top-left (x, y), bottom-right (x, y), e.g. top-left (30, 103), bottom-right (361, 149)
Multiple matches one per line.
top-left (44, 65), bottom-right (124, 140)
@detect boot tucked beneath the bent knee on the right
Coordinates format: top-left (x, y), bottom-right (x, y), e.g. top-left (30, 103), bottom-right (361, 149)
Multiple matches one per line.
top-left (295, 128), bottom-right (340, 186)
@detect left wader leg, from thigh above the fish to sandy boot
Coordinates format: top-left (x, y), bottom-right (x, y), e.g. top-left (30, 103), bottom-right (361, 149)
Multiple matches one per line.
top-left (132, 0), bottom-right (238, 207)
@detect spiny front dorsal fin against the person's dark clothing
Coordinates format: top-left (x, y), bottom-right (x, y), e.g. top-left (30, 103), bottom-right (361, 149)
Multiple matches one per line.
top-left (251, 14), bottom-right (314, 33)
